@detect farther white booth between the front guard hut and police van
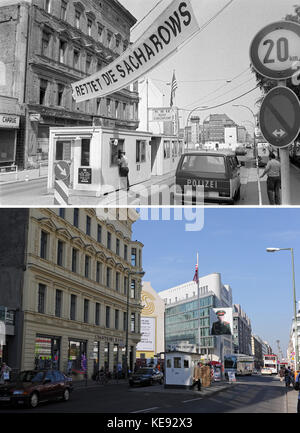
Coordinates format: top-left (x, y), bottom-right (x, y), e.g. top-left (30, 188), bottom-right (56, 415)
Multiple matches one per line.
top-left (150, 135), bottom-right (184, 176)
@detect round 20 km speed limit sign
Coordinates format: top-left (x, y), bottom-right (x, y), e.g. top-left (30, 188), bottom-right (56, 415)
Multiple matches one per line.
top-left (250, 21), bottom-right (300, 80)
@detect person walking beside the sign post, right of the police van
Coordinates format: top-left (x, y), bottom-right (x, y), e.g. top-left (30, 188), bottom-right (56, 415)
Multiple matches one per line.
top-left (260, 152), bottom-right (281, 205)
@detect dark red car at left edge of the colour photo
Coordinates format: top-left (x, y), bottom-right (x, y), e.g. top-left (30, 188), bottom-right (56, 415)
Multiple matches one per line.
top-left (0, 370), bottom-right (73, 408)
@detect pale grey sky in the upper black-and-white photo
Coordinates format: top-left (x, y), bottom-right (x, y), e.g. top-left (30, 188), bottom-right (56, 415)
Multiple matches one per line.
top-left (119, 0), bottom-right (300, 132)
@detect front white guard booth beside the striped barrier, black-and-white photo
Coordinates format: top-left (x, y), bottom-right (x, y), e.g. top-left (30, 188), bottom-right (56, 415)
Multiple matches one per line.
top-left (48, 126), bottom-right (152, 200)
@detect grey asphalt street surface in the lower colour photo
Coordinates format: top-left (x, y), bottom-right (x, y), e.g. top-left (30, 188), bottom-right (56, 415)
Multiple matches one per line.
top-left (0, 375), bottom-right (298, 414)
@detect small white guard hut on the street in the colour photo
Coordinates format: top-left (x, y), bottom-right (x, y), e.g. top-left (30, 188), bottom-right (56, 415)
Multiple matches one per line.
top-left (165, 351), bottom-right (201, 389)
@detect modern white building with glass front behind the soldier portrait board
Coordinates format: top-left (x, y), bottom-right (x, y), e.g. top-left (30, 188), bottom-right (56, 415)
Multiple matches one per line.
top-left (159, 273), bottom-right (233, 361)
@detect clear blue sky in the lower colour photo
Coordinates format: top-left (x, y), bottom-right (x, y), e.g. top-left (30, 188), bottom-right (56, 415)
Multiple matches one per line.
top-left (133, 207), bottom-right (300, 356)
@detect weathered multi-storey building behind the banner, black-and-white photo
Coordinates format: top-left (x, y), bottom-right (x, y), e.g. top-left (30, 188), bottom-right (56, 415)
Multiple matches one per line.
top-left (0, 0), bottom-right (139, 166)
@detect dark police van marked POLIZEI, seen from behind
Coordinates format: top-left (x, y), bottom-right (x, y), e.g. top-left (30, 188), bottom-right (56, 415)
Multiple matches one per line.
top-left (174, 150), bottom-right (241, 204)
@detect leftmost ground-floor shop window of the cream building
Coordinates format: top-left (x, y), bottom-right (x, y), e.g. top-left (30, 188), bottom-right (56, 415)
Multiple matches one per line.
top-left (34, 335), bottom-right (60, 370)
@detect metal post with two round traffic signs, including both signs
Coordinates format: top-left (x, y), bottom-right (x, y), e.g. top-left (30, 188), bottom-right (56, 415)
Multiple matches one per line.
top-left (250, 21), bottom-right (300, 205)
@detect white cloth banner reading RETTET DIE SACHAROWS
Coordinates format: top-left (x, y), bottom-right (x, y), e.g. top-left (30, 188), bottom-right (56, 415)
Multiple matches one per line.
top-left (72, 0), bottom-right (199, 102)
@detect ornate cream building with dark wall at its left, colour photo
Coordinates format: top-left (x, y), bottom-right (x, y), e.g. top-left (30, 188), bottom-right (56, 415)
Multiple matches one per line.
top-left (0, 208), bottom-right (143, 377)
